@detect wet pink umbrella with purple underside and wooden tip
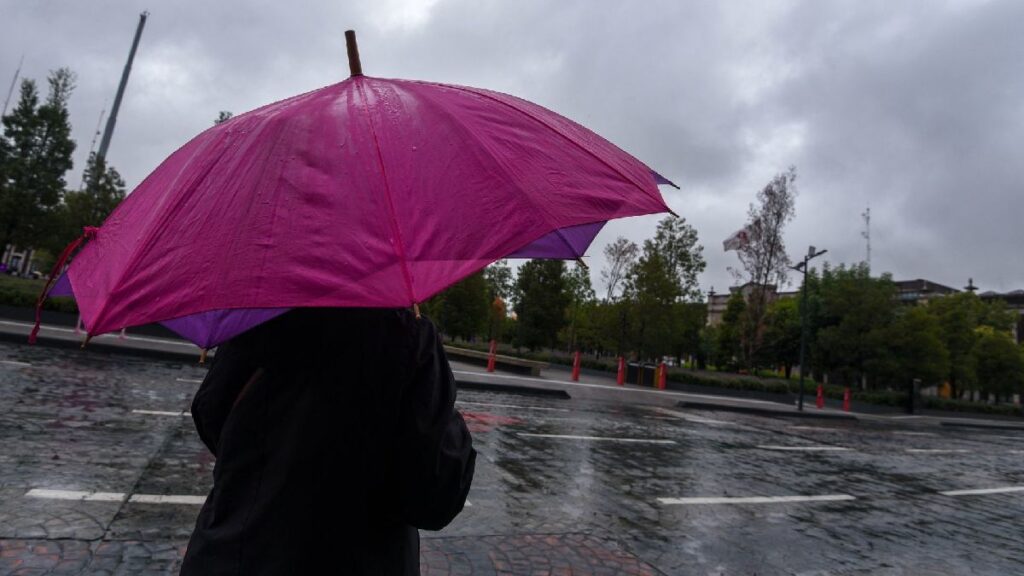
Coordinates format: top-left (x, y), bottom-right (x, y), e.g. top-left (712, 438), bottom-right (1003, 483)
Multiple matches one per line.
top-left (34, 33), bottom-right (671, 347)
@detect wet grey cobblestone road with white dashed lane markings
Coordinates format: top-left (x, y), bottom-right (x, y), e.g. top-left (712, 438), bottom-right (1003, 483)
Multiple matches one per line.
top-left (0, 343), bottom-right (1024, 575)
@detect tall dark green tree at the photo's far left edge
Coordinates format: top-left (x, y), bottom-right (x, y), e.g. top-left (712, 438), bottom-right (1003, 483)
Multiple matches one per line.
top-left (0, 68), bottom-right (75, 258)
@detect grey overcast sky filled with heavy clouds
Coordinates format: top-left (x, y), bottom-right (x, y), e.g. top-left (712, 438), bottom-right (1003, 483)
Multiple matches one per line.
top-left (0, 0), bottom-right (1024, 293)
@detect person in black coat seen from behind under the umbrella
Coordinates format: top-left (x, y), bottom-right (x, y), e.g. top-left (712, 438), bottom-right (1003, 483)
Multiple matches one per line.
top-left (181, 308), bottom-right (476, 576)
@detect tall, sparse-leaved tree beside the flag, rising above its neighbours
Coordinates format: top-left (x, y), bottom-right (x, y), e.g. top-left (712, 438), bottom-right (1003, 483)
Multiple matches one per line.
top-left (736, 167), bottom-right (797, 365)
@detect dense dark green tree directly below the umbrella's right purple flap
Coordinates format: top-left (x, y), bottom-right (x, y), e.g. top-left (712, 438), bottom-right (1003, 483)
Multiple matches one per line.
top-left (513, 259), bottom-right (570, 351)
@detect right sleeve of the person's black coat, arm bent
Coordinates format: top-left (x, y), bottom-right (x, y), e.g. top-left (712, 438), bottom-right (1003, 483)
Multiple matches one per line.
top-left (398, 319), bottom-right (476, 530)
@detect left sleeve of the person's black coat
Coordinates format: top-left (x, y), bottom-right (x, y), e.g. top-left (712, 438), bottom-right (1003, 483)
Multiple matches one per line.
top-left (191, 340), bottom-right (258, 456)
